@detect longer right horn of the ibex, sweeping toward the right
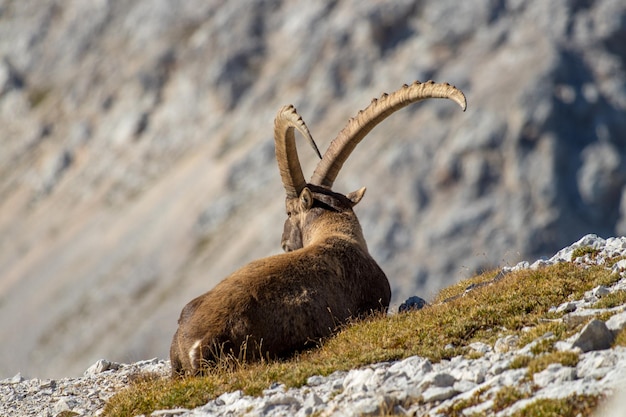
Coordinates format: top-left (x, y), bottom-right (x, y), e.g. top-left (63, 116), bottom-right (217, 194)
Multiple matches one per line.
top-left (311, 81), bottom-right (467, 188)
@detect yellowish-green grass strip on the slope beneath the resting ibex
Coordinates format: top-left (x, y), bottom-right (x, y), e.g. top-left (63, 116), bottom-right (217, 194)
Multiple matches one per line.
top-left (105, 263), bottom-right (619, 416)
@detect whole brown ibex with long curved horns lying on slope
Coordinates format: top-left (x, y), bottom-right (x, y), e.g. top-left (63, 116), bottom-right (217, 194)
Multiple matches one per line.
top-left (170, 81), bottom-right (466, 376)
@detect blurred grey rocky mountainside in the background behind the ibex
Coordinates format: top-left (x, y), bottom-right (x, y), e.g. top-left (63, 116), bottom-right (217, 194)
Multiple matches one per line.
top-left (0, 0), bottom-right (626, 377)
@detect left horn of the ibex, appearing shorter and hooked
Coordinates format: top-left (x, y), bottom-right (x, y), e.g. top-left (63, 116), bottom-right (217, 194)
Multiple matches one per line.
top-left (274, 105), bottom-right (322, 198)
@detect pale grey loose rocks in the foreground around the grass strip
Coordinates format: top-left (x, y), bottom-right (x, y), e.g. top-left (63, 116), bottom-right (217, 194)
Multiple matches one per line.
top-left (0, 235), bottom-right (626, 417)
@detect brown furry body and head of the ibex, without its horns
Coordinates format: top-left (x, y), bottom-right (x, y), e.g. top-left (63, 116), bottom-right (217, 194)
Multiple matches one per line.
top-left (170, 185), bottom-right (391, 375)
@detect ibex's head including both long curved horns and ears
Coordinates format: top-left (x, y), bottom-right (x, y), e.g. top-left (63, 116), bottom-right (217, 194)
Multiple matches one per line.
top-left (274, 81), bottom-right (467, 252)
